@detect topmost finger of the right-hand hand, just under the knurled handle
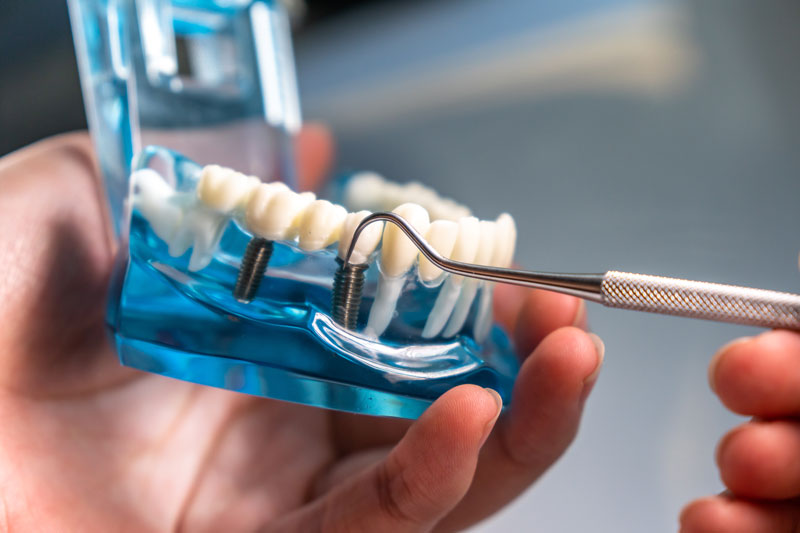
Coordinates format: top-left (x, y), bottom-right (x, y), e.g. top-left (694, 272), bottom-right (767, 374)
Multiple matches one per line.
top-left (709, 330), bottom-right (800, 418)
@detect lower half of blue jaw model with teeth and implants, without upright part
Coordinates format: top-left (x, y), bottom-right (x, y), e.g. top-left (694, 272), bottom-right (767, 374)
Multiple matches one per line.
top-left (117, 147), bottom-right (517, 417)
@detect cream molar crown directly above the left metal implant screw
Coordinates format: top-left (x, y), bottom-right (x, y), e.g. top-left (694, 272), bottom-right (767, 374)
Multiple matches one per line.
top-left (245, 184), bottom-right (313, 241)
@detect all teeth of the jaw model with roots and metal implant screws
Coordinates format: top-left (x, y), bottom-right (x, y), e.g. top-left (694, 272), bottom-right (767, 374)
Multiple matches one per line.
top-left (132, 165), bottom-right (516, 341)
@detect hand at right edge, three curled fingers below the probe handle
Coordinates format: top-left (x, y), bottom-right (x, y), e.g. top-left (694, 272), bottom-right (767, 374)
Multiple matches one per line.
top-left (681, 331), bottom-right (800, 533)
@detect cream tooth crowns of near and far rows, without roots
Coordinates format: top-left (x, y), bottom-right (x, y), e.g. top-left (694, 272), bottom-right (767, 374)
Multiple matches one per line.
top-left (197, 165), bottom-right (516, 282)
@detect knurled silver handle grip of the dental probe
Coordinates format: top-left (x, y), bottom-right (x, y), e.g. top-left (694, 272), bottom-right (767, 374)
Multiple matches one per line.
top-left (601, 270), bottom-right (800, 329)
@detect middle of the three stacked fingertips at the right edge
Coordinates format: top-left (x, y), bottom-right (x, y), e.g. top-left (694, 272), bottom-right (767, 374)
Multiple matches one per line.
top-left (717, 420), bottom-right (800, 499)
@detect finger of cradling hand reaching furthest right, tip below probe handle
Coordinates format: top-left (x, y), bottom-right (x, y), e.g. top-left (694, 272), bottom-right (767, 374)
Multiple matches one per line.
top-left (434, 328), bottom-right (604, 530)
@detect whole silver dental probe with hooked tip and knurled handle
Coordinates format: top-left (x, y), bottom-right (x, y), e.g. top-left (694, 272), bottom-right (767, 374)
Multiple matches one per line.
top-left (344, 213), bottom-right (800, 330)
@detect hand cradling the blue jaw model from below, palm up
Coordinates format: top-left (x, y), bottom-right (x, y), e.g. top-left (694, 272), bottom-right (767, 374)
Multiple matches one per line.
top-left (0, 126), bottom-right (603, 531)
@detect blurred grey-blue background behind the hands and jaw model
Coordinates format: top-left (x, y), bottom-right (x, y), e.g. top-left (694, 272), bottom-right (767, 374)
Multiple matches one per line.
top-left (0, 0), bottom-right (800, 532)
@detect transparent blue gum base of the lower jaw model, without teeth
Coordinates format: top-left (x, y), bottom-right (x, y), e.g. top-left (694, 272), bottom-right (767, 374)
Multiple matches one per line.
top-left (108, 148), bottom-right (518, 418)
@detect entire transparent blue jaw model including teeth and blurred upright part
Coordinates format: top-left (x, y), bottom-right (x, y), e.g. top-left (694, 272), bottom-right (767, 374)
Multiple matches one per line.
top-left (69, 0), bottom-right (517, 417)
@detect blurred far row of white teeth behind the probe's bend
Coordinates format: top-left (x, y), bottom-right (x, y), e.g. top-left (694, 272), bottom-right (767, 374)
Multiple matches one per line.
top-left (344, 172), bottom-right (471, 221)
